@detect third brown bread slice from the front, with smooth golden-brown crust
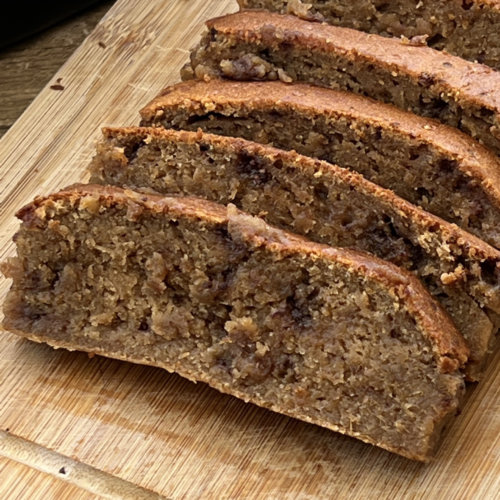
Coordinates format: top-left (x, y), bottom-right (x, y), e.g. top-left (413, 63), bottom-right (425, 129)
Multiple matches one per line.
top-left (141, 80), bottom-right (500, 248)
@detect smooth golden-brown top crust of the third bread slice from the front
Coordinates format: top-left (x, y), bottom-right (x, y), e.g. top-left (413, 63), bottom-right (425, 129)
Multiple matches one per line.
top-left (140, 80), bottom-right (500, 205)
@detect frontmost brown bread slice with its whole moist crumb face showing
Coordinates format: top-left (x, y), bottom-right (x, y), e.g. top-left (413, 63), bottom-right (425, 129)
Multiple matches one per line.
top-left (4, 186), bottom-right (467, 460)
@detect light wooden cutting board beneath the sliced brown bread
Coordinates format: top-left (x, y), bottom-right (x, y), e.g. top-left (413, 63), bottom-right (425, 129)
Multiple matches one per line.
top-left (0, 0), bottom-right (500, 499)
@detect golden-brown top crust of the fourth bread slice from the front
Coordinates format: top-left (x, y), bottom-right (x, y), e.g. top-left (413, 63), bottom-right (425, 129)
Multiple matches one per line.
top-left (206, 10), bottom-right (500, 114)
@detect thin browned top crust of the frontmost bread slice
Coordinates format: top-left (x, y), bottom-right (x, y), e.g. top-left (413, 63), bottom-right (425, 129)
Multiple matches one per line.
top-left (16, 184), bottom-right (468, 373)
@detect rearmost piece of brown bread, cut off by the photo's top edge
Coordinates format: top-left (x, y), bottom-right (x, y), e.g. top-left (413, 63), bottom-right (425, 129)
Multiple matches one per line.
top-left (238, 0), bottom-right (500, 70)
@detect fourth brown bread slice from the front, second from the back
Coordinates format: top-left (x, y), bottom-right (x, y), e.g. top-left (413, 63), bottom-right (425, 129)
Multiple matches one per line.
top-left (182, 11), bottom-right (500, 155)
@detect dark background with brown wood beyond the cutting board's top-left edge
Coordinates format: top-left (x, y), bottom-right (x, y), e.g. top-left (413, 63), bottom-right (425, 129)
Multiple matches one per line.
top-left (0, 0), bottom-right (113, 137)
